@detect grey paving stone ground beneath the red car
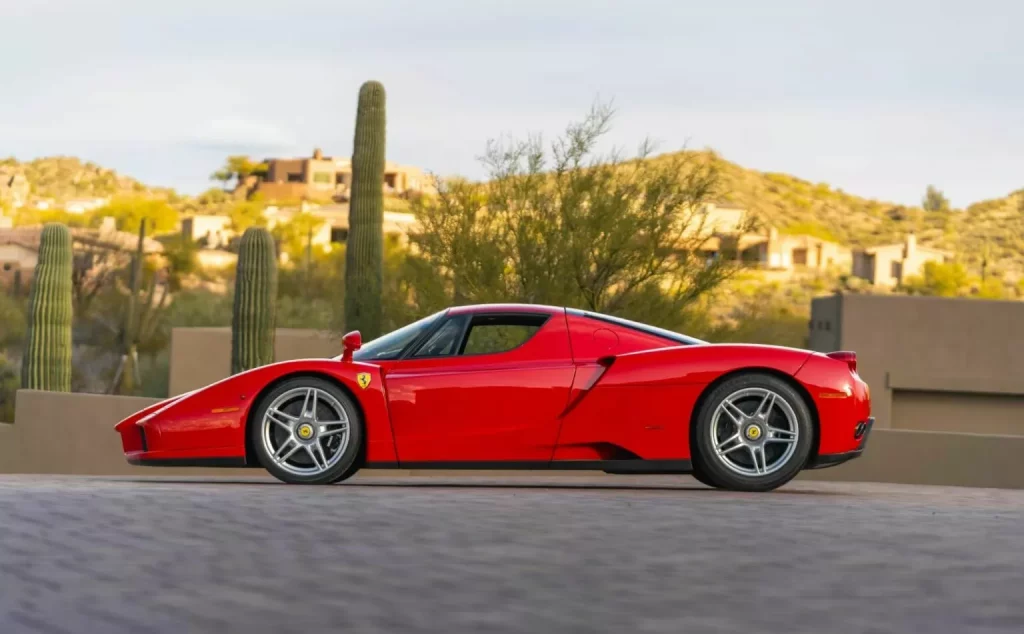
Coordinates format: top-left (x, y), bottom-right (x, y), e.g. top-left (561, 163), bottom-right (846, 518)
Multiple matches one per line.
top-left (0, 475), bottom-right (1024, 634)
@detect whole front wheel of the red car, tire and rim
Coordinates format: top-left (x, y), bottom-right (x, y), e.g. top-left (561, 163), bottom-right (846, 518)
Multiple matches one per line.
top-left (249, 377), bottom-right (364, 484)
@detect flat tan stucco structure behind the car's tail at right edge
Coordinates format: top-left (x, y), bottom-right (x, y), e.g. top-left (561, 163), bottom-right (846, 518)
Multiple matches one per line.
top-left (810, 294), bottom-right (1024, 436)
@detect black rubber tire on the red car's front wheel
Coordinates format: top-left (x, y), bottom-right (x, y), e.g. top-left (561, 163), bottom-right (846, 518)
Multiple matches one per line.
top-left (248, 376), bottom-right (365, 484)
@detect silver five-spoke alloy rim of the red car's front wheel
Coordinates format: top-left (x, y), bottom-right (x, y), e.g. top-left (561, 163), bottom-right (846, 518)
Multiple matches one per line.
top-left (261, 387), bottom-right (351, 475)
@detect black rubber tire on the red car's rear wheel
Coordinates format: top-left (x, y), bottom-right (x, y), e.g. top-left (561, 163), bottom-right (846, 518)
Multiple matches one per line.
top-left (692, 373), bottom-right (814, 492)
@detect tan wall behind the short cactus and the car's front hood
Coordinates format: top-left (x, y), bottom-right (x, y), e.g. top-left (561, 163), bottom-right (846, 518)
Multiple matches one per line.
top-left (168, 328), bottom-right (341, 396)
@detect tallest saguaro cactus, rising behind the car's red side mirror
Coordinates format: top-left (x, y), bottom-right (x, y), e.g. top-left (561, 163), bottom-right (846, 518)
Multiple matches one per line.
top-left (345, 81), bottom-right (386, 340)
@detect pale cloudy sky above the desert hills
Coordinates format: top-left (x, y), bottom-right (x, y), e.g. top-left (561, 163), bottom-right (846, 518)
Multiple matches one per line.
top-left (0, 0), bottom-right (1024, 206)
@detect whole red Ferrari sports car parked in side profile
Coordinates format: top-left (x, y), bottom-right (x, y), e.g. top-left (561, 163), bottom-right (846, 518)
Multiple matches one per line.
top-left (115, 304), bottom-right (873, 491)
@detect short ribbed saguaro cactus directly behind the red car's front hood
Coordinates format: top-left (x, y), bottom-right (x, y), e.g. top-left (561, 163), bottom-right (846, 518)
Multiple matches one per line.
top-left (231, 226), bottom-right (278, 374)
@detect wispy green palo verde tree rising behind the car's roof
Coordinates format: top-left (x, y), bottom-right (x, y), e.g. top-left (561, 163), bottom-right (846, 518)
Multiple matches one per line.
top-left (410, 105), bottom-right (745, 327)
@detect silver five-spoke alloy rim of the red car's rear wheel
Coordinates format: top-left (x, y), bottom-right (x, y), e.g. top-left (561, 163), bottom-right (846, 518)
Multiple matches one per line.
top-left (711, 387), bottom-right (800, 476)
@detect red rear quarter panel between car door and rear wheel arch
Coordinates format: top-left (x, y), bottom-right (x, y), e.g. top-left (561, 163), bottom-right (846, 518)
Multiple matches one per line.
top-left (555, 344), bottom-right (812, 460)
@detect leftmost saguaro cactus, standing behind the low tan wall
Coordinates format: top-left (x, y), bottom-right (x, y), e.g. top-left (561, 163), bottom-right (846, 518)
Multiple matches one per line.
top-left (22, 222), bottom-right (73, 392)
